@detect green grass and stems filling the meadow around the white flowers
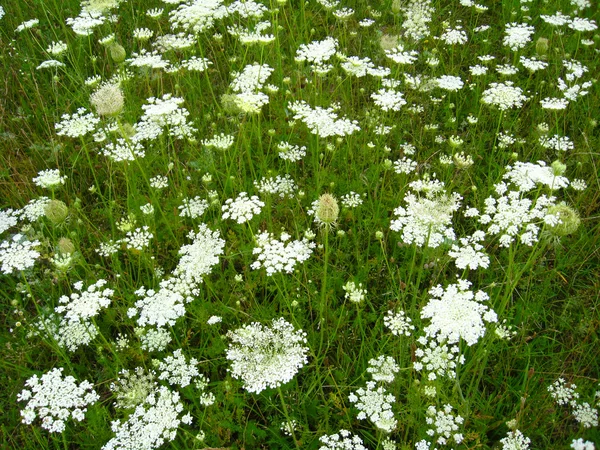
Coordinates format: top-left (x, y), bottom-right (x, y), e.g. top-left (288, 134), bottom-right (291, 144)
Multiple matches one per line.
top-left (0, 0), bottom-right (600, 450)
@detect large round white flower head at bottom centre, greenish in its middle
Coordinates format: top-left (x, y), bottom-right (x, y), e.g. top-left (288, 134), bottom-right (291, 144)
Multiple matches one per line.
top-left (226, 318), bottom-right (308, 394)
